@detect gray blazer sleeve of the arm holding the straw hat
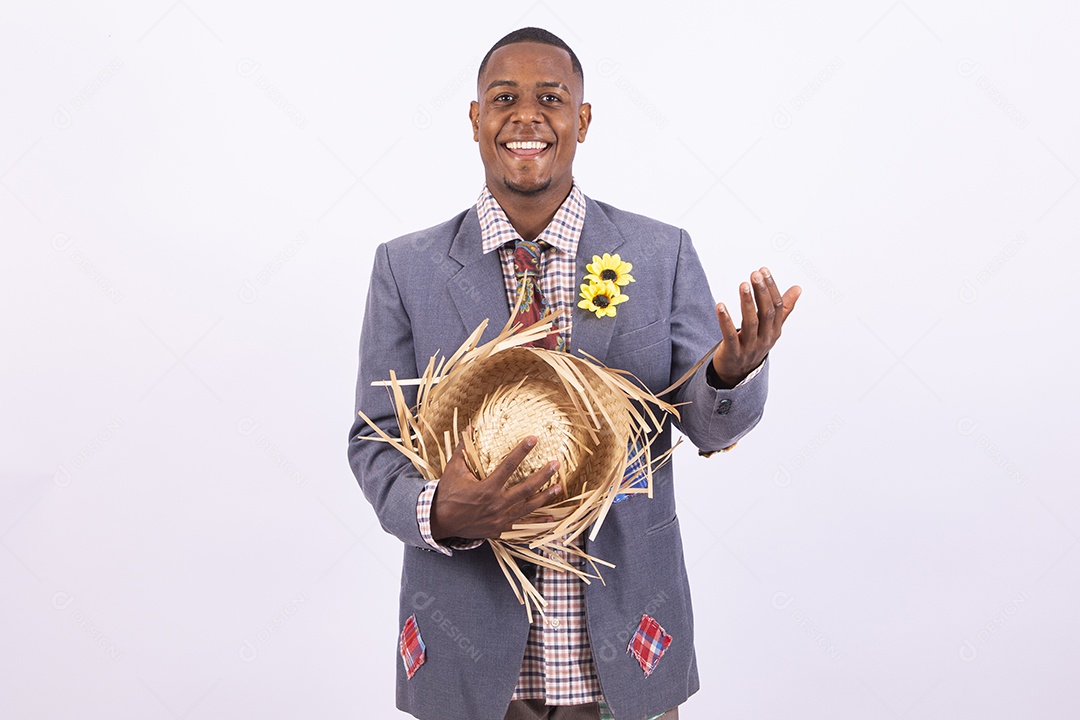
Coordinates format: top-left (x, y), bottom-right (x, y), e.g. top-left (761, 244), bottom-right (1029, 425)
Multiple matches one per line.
top-left (349, 244), bottom-right (430, 549)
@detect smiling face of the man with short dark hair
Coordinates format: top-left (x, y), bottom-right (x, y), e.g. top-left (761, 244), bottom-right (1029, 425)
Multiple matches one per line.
top-left (469, 42), bottom-right (592, 196)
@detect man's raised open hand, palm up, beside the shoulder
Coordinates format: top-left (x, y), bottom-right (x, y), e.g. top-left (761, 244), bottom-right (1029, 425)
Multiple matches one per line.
top-left (713, 268), bottom-right (802, 388)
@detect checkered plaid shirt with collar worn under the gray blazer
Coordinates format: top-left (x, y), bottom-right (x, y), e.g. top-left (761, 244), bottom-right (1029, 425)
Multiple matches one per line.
top-left (417, 184), bottom-right (602, 705)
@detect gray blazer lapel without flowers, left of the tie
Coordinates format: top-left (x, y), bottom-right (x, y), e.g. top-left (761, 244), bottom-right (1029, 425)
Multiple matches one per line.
top-left (449, 207), bottom-right (510, 341)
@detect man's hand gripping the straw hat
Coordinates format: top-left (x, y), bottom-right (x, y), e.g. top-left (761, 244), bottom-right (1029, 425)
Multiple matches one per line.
top-left (431, 430), bottom-right (563, 541)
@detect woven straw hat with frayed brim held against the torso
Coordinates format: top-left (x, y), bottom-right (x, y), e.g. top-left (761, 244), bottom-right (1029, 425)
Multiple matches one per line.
top-left (360, 314), bottom-right (700, 620)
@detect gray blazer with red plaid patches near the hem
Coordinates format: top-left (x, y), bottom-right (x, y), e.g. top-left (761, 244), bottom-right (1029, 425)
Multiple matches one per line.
top-left (349, 199), bottom-right (768, 720)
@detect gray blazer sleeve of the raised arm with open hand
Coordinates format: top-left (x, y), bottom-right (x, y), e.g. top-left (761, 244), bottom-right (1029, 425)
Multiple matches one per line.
top-left (671, 230), bottom-right (769, 452)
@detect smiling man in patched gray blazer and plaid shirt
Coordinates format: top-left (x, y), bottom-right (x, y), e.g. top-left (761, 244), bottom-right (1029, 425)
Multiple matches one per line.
top-left (349, 28), bottom-right (800, 720)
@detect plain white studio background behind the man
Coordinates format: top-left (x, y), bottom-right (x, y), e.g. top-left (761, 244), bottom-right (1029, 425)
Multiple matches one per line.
top-left (0, 0), bottom-right (1080, 720)
